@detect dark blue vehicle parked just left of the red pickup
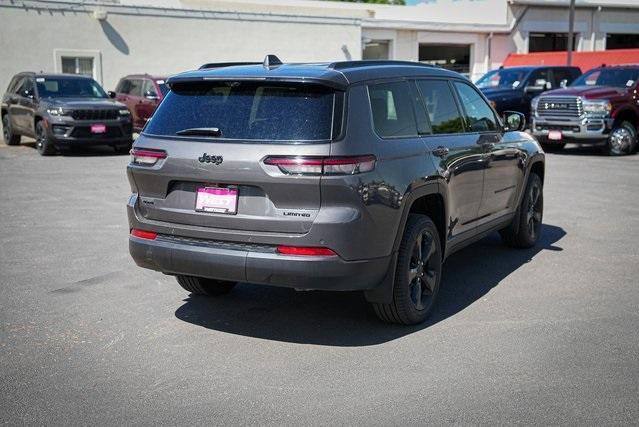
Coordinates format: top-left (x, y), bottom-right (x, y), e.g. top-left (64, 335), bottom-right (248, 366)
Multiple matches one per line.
top-left (477, 66), bottom-right (581, 118)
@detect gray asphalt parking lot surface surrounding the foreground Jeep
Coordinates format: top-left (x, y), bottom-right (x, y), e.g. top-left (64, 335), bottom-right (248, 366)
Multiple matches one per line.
top-left (0, 144), bottom-right (639, 425)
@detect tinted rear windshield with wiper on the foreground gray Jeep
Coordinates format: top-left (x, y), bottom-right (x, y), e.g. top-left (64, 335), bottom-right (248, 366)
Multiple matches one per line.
top-left (144, 82), bottom-right (337, 141)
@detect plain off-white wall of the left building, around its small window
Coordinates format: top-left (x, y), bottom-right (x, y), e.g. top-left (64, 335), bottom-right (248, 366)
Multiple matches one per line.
top-left (0, 6), bottom-right (361, 92)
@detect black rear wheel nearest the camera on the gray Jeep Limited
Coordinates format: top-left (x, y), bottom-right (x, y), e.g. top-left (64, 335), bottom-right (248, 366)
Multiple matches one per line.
top-left (373, 214), bottom-right (442, 325)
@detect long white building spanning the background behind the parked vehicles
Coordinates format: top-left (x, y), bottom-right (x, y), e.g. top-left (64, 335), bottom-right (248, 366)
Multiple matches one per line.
top-left (0, 0), bottom-right (639, 91)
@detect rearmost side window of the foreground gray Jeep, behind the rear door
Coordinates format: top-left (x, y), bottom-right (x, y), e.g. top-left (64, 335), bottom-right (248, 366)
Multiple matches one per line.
top-left (368, 82), bottom-right (417, 138)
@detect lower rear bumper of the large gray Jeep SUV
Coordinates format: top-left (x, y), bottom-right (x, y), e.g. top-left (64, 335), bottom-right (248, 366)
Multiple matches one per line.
top-left (129, 235), bottom-right (391, 291)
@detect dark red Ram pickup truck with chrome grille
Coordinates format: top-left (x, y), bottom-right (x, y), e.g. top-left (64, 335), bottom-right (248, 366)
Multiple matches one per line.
top-left (532, 65), bottom-right (639, 155)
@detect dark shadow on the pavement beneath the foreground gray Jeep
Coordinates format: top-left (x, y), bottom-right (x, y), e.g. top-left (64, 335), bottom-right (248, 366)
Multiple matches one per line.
top-left (175, 225), bottom-right (566, 347)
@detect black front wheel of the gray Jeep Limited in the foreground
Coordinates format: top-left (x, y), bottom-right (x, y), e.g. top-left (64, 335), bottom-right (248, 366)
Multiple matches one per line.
top-left (499, 172), bottom-right (544, 248)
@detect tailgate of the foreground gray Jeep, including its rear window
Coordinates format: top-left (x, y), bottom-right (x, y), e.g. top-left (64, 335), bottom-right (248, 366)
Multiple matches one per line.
top-left (129, 81), bottom-right (341, 235)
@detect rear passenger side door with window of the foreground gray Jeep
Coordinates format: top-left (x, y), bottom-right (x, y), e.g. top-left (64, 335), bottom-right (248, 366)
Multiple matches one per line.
top-left (417, 79), bottom-right (486, 238)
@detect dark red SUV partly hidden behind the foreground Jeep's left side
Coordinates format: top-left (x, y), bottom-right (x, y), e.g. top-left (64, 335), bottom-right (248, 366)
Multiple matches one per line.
top-left (109, 74), bottom-right (169, 132)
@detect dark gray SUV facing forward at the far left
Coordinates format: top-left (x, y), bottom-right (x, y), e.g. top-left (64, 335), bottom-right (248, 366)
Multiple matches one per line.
top-left (0, 72), bottom-right (132, 155)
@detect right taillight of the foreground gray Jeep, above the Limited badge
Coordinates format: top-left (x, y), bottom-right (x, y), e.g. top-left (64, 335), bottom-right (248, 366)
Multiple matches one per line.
top-left (264, 155), bottom-right (376, 175)
